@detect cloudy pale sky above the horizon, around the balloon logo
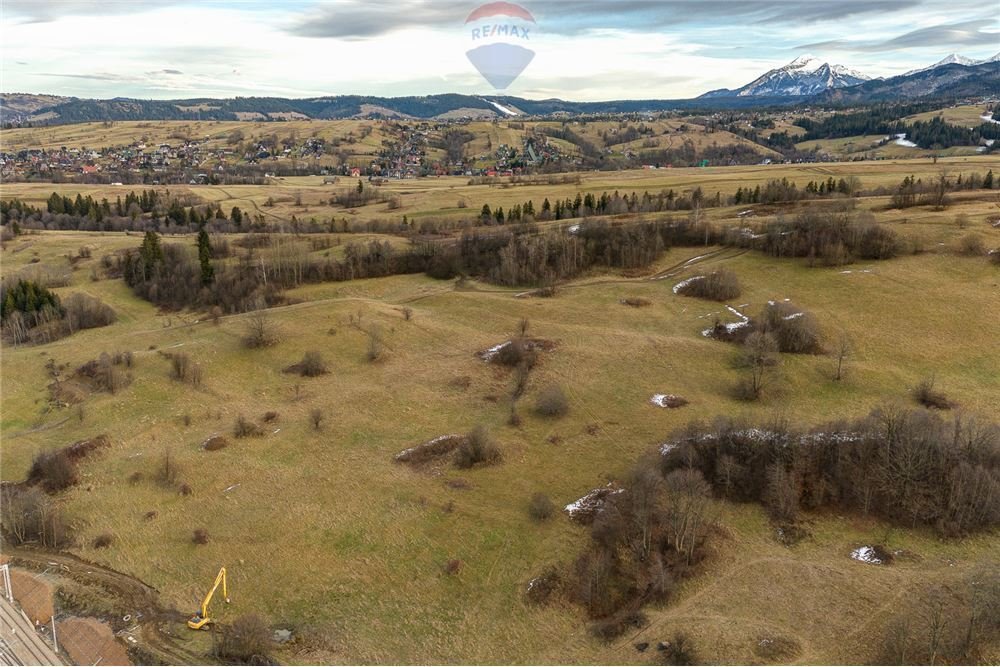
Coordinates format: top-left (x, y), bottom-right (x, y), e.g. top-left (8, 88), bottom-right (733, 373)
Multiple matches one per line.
top-left (0, 0), bottom-right (1000, 101)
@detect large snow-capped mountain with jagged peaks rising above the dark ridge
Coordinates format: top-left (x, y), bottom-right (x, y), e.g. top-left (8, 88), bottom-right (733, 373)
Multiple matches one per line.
top-left (702, 55), bottom-right (871, 97)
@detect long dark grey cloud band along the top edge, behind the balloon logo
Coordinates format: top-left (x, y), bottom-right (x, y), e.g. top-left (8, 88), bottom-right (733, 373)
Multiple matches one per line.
top-left (286, 0), bottom-right (924, 39)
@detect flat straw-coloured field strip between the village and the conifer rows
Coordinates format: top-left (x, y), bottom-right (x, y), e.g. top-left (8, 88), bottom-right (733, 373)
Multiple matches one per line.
top-left (0, 157), bottom-right (1000, 232)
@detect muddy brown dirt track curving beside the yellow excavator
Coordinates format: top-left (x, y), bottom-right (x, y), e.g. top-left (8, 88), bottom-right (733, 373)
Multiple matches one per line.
top-left (5, 547), bottom-right (211, 665)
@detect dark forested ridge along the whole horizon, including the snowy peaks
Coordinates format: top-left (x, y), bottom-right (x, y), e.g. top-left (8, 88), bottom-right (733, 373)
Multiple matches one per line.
top-left (0, 57), bottom-right (1000, 125)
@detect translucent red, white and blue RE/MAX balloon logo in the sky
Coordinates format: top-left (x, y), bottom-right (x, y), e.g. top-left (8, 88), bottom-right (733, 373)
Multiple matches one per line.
top-left (465, 2), bottom-right (536, 90)
